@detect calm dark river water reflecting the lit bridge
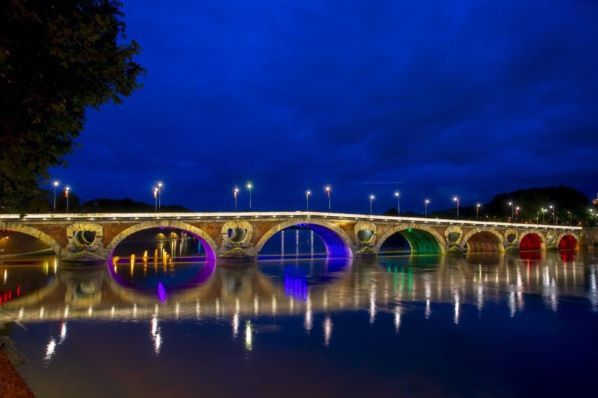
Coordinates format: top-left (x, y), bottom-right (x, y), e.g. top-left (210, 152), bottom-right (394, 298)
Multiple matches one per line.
top-left (0, 253), bottom-right (598, 397)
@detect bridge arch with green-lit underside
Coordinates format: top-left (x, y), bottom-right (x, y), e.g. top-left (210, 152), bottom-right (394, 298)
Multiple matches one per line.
top-left (375, 225), bottom-right (446, 254)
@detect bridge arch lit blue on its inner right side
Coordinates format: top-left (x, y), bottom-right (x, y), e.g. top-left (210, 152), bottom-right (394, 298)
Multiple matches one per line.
top-left (255, 219), bottom-right (353, 258)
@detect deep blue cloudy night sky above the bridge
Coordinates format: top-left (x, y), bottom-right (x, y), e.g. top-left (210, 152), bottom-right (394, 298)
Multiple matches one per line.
top-left (52, 0), bottom-right (598, 212)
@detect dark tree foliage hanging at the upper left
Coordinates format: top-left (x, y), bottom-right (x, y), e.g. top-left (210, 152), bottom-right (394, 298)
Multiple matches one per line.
top-left (0, 0), bottom-right (143, 211)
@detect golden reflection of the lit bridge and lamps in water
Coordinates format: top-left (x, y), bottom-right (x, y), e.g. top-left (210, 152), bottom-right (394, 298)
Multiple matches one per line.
top-left (0, 253), bottom-right (598, 352)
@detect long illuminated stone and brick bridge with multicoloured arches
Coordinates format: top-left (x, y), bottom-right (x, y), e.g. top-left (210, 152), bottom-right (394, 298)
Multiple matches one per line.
top-left (0, 211), bottom-right (583, 261)
